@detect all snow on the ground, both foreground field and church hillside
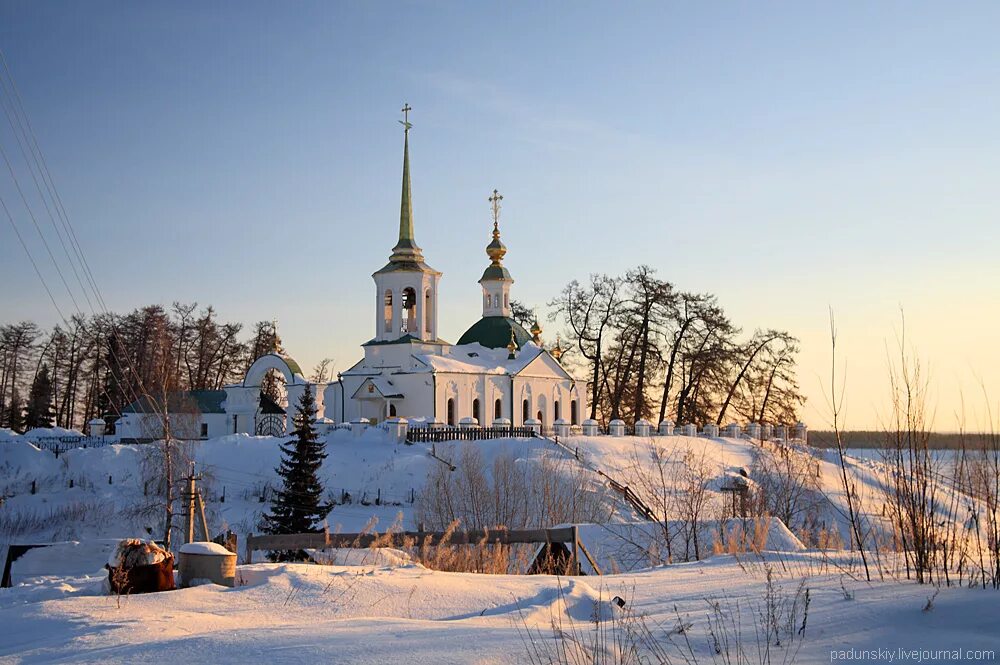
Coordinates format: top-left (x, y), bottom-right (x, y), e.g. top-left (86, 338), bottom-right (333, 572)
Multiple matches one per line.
top-left (0, 430), bottom-right (1000, 663)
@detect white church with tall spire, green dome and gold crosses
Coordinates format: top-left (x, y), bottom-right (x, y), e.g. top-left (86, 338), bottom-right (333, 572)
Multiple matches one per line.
top-left (323, 113), bottom-right (586, 428)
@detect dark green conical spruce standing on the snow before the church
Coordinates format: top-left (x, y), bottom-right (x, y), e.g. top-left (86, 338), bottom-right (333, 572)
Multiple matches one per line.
top-left (264, 386), bottom-right (331, 561)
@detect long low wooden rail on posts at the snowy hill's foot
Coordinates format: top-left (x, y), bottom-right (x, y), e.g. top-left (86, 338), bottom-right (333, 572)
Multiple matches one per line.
top-left (246, 525), bottom-right (601, 575)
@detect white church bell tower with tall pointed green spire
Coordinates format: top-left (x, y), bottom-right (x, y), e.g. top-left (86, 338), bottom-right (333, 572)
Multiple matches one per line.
top-left (372, 104), bottom-right (441, 342)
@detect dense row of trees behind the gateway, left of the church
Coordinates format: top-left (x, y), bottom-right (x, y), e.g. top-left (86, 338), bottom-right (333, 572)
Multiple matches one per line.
top-left (0, 303), bottom-right (280, 431)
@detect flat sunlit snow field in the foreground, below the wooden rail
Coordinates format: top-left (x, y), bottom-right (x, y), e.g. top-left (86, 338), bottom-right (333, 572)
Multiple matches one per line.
top-left (0, 553), bottom-right (1000, 664)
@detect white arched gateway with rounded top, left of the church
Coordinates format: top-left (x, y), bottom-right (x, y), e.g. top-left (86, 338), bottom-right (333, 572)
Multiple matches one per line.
top-left (226, 353), bottom-right (312, 435)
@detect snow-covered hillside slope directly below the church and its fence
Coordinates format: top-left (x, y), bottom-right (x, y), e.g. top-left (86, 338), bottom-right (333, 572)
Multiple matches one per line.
top-left (0, 428), bottom-right (980, 560)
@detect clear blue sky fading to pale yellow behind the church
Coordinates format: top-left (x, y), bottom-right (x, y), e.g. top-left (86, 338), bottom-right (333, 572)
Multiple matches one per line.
top-left (0, 0), bottom-right (1000, 430)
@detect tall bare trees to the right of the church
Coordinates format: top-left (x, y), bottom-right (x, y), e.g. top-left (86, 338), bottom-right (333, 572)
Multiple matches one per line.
top-left (549, 265), bottom-right (805, 425)
